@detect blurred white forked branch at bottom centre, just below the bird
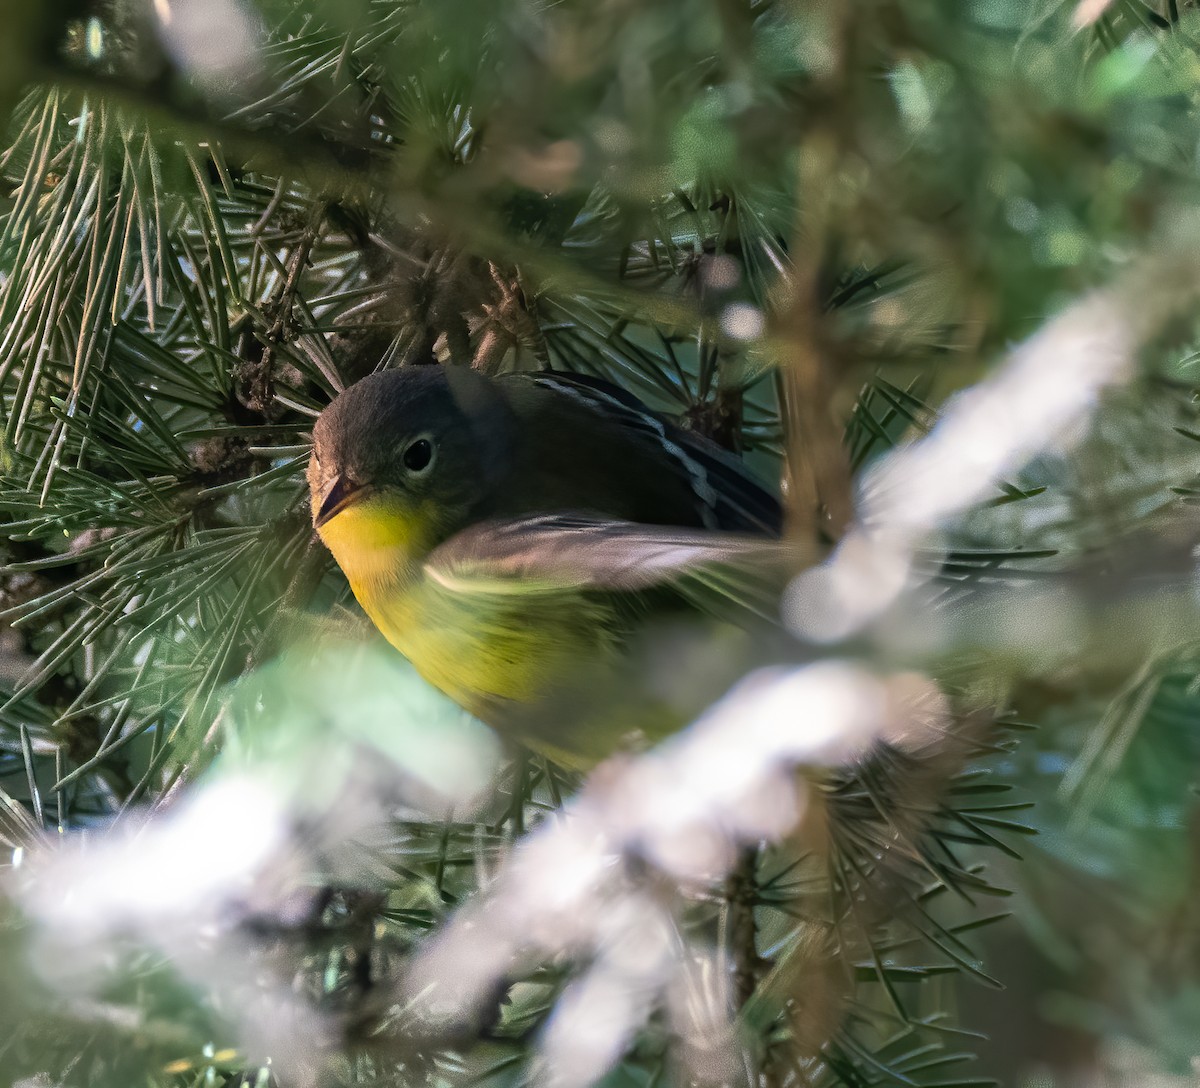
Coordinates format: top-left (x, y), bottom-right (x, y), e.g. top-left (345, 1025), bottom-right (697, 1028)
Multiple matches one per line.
top-left (406, 661), bottom-right (948, 1088)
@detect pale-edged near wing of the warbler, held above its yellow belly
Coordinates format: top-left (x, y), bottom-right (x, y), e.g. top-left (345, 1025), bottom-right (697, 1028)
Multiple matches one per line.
top-left (425, 515), bottom-right (794, 624)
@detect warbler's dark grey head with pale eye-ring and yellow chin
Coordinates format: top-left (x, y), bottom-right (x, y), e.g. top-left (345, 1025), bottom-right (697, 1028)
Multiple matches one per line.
top-left (308, 366), bottom-right (511, 573)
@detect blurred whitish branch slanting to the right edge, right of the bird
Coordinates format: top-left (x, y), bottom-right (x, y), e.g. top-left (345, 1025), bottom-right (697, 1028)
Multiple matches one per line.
top-left (785, 221), bottom-right (1200, 642)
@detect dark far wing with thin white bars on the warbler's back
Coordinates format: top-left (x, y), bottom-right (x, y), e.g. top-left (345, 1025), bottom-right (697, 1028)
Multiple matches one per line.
top-left (512, 371), bottom-right (784, 536)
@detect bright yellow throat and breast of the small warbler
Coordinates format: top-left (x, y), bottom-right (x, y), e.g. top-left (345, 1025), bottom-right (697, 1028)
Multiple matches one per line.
top-left (319, 497), bottom-right (690, 770)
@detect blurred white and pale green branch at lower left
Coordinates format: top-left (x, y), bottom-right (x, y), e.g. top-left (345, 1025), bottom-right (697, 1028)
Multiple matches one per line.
top-left (8, 644), bottom-right (497, 1088)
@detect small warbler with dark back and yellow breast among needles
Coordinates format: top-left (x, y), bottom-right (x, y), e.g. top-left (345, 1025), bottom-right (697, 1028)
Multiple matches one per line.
top-left (308, 366), bottom-right (782, 768)
